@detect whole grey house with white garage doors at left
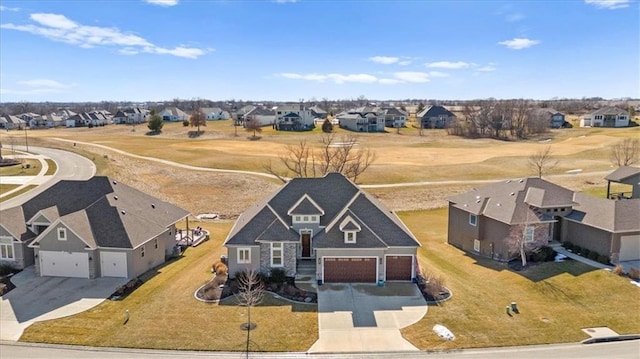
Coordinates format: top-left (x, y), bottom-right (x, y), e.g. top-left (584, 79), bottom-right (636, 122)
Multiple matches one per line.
top-left (0, 177), bottom-right (189, 278)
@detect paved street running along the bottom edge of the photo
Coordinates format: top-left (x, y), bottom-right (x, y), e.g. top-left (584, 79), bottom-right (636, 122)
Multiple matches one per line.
top-left (0, 340), bottom-right (640, 359)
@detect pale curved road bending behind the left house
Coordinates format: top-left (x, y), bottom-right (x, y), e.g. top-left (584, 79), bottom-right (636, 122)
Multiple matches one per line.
top-left (0, 146), bottom-right (96, 209)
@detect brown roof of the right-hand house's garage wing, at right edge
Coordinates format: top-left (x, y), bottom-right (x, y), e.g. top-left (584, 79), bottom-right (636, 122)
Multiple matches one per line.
top-left (566, 193), bottom-right (640, 233)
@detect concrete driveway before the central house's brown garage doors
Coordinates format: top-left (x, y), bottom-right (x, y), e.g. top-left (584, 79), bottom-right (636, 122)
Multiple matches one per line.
top-left (309, 282), bottom-right (427, 353)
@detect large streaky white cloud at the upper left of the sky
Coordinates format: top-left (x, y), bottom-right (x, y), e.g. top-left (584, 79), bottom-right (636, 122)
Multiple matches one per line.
top-left (0, 13), bottom-right (212, 59)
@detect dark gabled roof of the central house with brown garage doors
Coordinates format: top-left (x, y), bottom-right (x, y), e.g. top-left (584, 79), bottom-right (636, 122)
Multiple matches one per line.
top-left (225, 173), bottom-right (420, 248)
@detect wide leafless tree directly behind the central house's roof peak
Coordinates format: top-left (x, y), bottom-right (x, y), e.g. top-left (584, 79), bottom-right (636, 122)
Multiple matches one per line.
top-left (264, 133), bottom-right (375, 182)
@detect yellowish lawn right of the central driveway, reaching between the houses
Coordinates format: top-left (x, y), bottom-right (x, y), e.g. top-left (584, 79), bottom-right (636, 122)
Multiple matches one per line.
top-left (400, 208), bottom-right (640, 350)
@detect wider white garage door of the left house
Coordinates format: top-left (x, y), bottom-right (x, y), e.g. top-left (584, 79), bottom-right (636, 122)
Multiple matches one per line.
top-left (39, 251), bottom-right (89, 278)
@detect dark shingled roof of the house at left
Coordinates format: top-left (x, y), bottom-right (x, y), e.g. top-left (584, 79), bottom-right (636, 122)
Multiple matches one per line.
top-left (0, 177), bottom-right (189, 248)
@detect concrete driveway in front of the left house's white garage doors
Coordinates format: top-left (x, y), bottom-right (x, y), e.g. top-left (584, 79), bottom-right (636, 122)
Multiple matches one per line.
top-left (0, 266), bottom-right (127, 341)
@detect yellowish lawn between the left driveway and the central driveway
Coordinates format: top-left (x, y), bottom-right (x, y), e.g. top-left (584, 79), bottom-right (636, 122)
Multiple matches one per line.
top-left (20, 223), bottom-right (318, 351)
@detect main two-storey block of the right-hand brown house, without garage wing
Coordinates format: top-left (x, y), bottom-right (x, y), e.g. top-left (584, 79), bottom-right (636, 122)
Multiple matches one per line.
top-left (447, 178), bottom-right (575, 261)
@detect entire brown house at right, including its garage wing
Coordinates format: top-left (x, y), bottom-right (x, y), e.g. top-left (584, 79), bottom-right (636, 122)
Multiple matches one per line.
top-left (447, 167), bottom-right (640, 263)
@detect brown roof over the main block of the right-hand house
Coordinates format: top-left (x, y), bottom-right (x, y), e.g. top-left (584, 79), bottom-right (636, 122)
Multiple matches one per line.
top-left (449, 177), bottom-right (575, 224)
